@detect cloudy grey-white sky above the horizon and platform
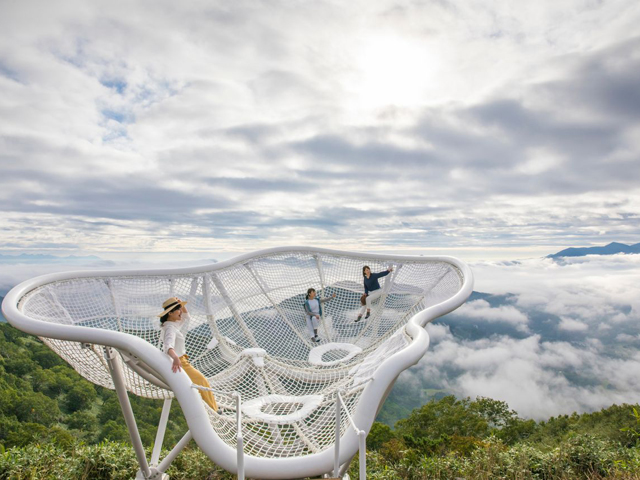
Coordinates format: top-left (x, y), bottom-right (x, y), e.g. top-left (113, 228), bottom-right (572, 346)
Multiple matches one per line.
top-left (0, 0), bottom-right (640, 261)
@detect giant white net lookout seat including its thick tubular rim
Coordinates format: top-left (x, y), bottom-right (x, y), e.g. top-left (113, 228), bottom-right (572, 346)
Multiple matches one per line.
top-left (2, 247), bottom-right (472, 478)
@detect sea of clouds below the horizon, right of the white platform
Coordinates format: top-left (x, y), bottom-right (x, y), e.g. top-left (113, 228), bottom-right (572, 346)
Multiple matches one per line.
top-left (392, 255), bottom-right (640, 420)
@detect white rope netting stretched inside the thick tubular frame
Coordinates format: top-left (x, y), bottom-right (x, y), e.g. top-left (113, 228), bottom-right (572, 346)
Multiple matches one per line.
top-left (2, 248), bottom-right (470, 478)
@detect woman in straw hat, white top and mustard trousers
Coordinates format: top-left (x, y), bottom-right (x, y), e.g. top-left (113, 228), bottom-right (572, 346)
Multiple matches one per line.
top-left (158, 297), bottom-right (218, 412)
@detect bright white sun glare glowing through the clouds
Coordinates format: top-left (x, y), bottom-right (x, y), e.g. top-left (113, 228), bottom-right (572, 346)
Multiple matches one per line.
top-left (354, 36), bottom-right (439, 108)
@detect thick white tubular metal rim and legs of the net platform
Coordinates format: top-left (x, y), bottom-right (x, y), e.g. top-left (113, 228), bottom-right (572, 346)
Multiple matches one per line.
top-left (2, 247), bottom-right (473, 479)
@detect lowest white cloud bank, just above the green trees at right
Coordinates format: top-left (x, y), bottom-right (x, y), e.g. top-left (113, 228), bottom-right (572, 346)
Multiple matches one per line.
top-left (408, 335), bottom-right (640, 420)
